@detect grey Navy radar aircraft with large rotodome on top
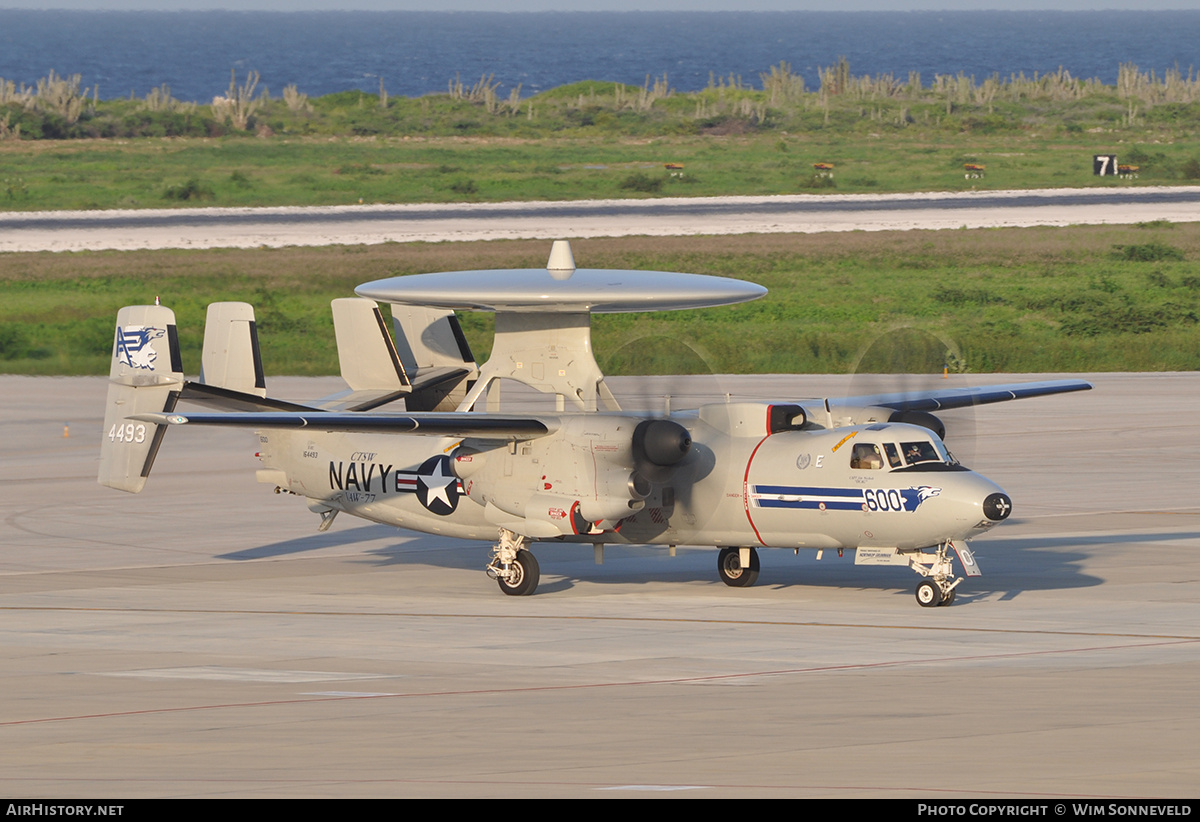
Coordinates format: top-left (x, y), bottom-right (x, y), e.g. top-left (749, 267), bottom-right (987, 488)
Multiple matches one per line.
top-left (100, 241), bottom-right (1091, 607)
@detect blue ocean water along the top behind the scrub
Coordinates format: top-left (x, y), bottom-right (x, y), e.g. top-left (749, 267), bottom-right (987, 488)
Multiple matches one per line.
top-left (0, 10), bottom-right (1200, 102)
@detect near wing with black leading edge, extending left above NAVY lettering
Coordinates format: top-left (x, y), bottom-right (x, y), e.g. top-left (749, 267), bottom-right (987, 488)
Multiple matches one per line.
top-left (128, 412), bottom-right (558, 439)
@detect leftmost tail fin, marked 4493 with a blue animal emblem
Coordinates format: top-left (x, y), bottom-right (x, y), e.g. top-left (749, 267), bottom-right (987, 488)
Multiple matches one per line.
top-left (97, 306), bottom-right (184, 493)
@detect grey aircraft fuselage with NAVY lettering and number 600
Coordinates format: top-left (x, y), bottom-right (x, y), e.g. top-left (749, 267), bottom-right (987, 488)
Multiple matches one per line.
top-left (259, 403), bottom-right (1012, 551)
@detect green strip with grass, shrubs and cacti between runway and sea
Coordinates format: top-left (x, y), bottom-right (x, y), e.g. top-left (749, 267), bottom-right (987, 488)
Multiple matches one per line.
top-left (7, 66), bottom-right (1200, 210)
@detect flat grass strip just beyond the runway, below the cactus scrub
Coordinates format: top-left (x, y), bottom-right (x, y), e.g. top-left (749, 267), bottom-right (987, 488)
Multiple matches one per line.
top-left (0, 133), bottom-right (1198, 211)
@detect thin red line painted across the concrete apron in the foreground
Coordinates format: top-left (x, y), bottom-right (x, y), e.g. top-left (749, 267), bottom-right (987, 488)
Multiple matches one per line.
top-left (0, 638), bottom-right (1200, 727)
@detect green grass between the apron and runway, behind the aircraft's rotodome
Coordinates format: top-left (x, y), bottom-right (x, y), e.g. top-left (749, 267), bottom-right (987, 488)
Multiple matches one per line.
top-left (0, 222), bottom-right (1200, 374)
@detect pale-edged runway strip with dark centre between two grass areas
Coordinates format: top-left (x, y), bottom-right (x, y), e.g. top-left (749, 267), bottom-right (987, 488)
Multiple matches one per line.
top-left (0, 186), bottom-right (1200, 252)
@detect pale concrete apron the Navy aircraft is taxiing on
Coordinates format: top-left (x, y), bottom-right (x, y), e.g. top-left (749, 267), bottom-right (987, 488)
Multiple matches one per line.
top-left (0, 373), bottom-right (1200, 799)
